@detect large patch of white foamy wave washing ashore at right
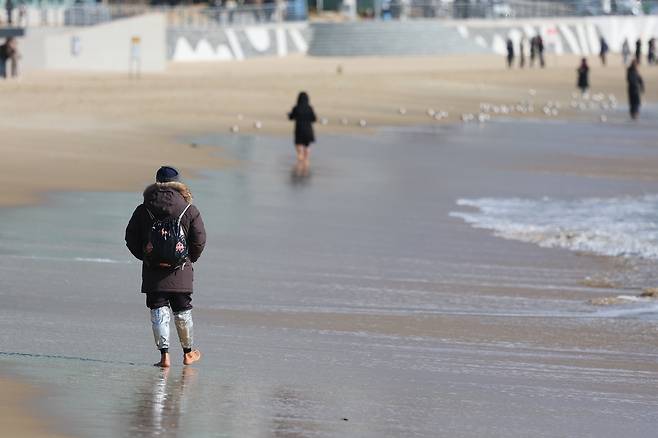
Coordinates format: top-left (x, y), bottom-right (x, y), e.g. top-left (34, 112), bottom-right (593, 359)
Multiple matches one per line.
top-left (450, 195), bottom-right (658, 259)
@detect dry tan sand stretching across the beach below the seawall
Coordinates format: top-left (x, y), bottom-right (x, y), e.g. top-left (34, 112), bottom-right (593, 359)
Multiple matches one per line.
top-left (0, 56), bottom-right (658, 205)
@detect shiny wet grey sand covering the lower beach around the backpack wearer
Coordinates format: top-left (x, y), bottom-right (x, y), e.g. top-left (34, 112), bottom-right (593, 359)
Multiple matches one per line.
top-left (0, 118), bottom-right (658, 437)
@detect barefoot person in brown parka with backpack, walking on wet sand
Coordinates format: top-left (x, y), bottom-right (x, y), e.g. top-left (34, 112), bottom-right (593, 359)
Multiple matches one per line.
top-left (126, 166), bottom-right (206, 368)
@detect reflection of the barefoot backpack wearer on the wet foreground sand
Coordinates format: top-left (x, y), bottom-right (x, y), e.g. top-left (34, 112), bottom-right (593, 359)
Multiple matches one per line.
top-left (129, 367), bottom-right (197, 436)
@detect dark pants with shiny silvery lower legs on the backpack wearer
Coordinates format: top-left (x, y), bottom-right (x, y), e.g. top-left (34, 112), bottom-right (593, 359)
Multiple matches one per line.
top-left (146, 292), bottom-right (194, 350)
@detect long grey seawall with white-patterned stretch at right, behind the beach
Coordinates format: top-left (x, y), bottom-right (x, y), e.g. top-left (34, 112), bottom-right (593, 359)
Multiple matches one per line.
top-left (308, 16), bottom-right (658, 56)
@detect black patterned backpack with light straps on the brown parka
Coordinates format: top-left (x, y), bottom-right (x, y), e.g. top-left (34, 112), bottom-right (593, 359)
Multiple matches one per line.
top-left (144, 204), bottom-right (190, 269)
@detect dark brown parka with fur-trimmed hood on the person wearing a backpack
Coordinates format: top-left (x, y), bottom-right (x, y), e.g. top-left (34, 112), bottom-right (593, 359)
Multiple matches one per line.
top-left (126, 182), bottom-right (206, 293)
